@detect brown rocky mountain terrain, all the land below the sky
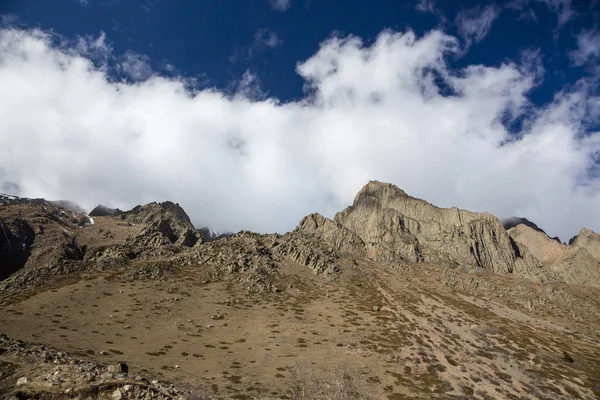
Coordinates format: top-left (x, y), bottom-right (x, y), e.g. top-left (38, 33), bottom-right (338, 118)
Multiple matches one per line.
top-left (0, 182), bottom-right (600, 400)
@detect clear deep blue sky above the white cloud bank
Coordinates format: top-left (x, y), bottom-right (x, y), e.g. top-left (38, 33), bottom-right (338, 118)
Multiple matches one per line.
top-left (2, 0), bottom-right (600, 102)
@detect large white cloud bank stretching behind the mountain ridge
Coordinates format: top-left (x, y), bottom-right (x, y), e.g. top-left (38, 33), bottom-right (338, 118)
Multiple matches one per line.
top-left (0, 29), bottom-right (600, 239)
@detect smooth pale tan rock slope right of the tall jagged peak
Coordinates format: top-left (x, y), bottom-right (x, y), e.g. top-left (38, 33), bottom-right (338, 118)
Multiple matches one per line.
top-left (508, 224), bottom-right (568, 265)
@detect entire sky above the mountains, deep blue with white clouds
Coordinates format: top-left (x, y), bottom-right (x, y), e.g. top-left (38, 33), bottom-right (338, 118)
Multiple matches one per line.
top-left (0, 0), bottom-right (600, 241)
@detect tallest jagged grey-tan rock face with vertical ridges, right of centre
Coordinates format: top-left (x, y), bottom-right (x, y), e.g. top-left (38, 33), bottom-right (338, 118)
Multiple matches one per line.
top-left (314, 181), bottom-right (541, 276)
